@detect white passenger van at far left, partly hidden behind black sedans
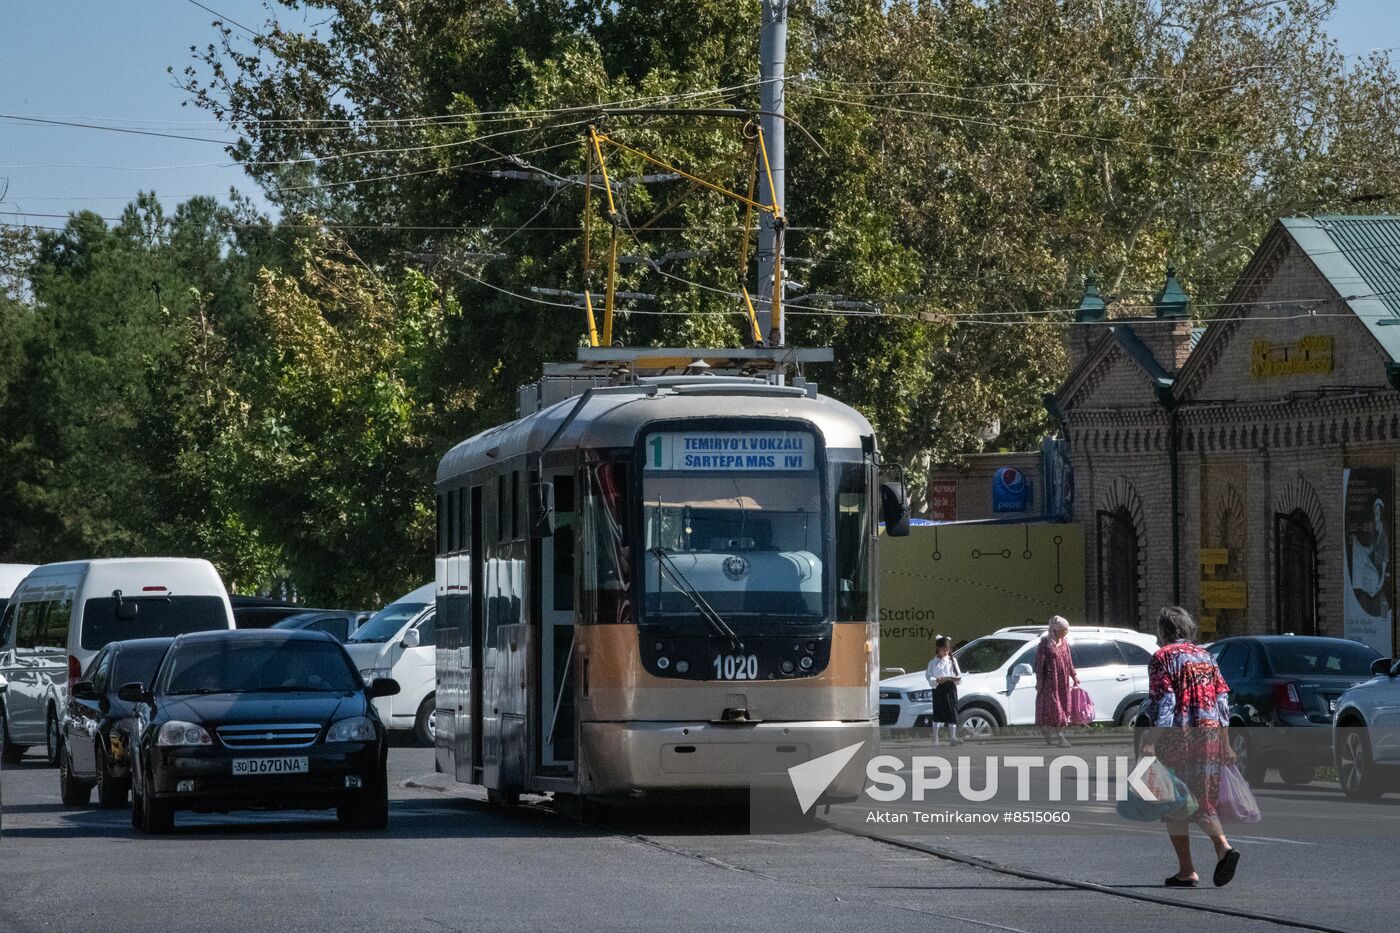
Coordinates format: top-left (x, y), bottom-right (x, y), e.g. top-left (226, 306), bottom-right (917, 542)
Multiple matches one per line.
top-left (0, 558), bottom-right (234, 763)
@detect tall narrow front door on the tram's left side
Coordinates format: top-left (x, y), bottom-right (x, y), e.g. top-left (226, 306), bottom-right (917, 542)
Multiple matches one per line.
top-left (539, 474), bottom-right (578, 775)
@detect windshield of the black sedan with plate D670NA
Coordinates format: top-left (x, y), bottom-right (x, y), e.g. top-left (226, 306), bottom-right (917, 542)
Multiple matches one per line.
top-left (162, 639), bottom-right (360, 695)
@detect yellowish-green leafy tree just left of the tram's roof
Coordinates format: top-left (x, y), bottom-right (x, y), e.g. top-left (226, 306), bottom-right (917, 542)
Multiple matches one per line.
top-left (213, 234), bottom-right (459, 605)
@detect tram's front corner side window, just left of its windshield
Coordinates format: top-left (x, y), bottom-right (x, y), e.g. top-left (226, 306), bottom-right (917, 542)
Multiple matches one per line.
top-left (580, 464), bottom-right (631, 623)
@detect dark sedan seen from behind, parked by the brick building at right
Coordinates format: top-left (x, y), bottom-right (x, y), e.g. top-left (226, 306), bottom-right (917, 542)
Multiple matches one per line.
top-left (1207, 635), bottom-right (1380, 785)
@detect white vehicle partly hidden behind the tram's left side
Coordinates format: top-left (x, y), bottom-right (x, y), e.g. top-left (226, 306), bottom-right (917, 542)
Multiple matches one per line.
top-left (346, 583), bottom-right (437, 745)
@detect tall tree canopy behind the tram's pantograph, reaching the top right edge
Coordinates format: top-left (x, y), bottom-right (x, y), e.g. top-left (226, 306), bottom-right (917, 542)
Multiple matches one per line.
top-left (185, 0), bottom-right (1400, 479)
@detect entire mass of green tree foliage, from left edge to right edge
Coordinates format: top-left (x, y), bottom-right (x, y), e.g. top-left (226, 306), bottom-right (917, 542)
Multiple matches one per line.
top-left (0, 0), bottom-right (1400, 604)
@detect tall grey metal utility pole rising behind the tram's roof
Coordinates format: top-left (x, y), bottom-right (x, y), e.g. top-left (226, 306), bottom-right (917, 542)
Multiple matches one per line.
top-left (755, 0), bottom-right (788, 346)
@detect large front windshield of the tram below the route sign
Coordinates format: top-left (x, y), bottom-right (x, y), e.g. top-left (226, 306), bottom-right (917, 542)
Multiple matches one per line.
top-left (641, 469), bottom-right (826, 625)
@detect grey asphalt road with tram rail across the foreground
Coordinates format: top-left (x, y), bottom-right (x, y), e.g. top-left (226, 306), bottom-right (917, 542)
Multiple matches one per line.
top-left (0, 748), bottom-right (1400, 933)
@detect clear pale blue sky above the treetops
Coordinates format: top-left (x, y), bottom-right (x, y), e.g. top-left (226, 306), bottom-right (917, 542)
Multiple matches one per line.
top-left (0, 0), bottom-right (1400, 226)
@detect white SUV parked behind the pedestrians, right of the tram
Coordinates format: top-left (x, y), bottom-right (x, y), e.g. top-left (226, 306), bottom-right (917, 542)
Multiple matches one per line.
top-left (879, 625), bottom-right (1156, 738)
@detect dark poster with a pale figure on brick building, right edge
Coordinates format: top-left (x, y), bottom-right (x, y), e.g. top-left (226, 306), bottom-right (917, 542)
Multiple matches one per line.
top-left (1341, 467), bottom-right (1394, 657)
